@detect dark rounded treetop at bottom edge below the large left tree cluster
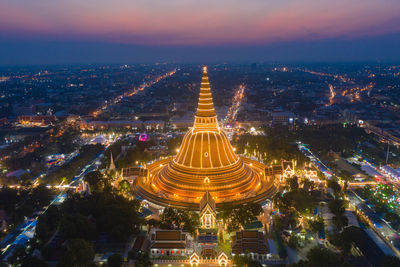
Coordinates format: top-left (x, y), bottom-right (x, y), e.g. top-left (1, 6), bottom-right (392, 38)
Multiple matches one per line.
top-left (58, 239), bottom-right (94, 267)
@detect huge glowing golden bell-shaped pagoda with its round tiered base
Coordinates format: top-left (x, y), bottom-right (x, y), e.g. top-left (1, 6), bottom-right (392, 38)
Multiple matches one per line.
top-left (134, 67), bottom-right (275, 209)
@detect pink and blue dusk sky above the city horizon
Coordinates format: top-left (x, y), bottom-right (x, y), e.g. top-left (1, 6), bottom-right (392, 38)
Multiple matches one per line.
top-left (0, 0), bottom-right (400, 65)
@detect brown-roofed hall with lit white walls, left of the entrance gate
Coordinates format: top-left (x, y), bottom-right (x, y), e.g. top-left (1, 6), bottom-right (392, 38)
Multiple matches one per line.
top-left (150, 229), bottom-right (193, 258)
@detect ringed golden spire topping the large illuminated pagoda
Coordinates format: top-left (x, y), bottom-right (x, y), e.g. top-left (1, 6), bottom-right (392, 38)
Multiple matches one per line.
top-left (194, 66), bottom-right (218, 130)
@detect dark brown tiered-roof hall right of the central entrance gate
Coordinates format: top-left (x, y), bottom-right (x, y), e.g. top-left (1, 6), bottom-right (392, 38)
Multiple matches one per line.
top-left (232, 230), bottom-right (269, 260)
